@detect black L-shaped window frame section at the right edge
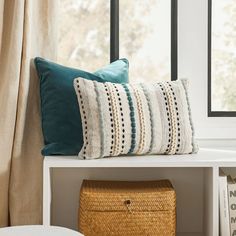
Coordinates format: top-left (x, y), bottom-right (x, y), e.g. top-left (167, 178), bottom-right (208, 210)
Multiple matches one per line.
top-left (208, 0), bottom-right (236, 117)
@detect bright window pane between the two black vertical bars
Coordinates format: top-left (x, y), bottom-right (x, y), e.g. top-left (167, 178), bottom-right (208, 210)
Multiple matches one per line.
top-left (120, 0), bottom-right (171, 82)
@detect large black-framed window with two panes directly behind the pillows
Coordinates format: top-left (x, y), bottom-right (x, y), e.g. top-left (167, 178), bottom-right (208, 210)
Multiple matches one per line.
top-left (58, 0), bottom-right (177, 82)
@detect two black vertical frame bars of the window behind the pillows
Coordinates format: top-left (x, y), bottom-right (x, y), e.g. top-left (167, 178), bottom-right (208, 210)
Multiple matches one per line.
top-left (110, 0), bottom-right (178, 80)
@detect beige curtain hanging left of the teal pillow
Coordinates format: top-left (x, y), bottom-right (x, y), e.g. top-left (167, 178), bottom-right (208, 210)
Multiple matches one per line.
top-left (0, 0), bottom-right (58, 226)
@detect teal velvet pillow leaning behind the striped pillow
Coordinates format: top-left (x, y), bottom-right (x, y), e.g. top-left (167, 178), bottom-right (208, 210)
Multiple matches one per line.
top-left (34, 57), bottom-right (129, 156)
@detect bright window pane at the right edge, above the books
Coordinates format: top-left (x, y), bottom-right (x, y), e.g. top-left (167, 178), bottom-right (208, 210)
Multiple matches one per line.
top-left (211, 0), bottom-right (236, 111)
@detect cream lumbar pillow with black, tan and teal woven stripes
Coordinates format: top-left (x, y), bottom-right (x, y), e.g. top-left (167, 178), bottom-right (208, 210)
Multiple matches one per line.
top-left (74, 78), bottom-right (197, 159)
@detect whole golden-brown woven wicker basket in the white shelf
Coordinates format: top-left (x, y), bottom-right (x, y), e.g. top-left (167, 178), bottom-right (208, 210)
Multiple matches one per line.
top-left (79, 180), bottom-right (176, 236)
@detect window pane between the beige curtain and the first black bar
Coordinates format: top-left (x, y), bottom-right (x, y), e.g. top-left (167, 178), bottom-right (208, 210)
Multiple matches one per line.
top-left (58, 0), bottom-right (110, 71)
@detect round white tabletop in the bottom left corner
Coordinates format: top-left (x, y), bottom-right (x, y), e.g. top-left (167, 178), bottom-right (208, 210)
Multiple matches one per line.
top-left (0, 225), bottom-right (82, 236)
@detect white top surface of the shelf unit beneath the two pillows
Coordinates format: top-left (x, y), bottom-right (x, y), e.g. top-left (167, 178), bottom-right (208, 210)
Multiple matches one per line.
top-left (44, 148), bottom-right (236, 168)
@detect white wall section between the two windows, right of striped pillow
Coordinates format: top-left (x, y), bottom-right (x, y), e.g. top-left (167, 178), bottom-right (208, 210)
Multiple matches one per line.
top-left (178, 0), bottom-right (236, 139)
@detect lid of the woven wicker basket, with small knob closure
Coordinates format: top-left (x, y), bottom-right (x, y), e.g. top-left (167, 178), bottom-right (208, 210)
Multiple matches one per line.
top-left (80, 180), bottom-right (176, 212)
